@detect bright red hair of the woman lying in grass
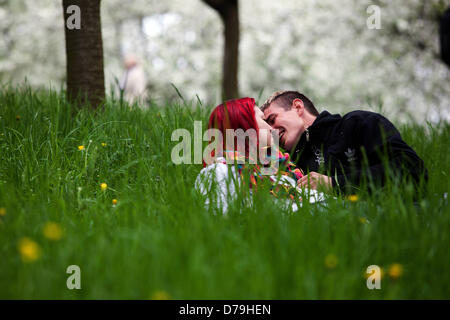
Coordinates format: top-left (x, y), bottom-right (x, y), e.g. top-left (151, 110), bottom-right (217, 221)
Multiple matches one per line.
top-left (208, 98), bottom-right (258, 162)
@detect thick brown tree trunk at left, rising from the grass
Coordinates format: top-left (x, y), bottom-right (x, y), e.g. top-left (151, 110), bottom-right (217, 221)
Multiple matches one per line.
top-left (63, 0), bottom-right (105, 108)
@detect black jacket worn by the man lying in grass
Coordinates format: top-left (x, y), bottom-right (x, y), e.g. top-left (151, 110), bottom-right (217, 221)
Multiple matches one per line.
top-left (292, 110), bottom-right (428, 193)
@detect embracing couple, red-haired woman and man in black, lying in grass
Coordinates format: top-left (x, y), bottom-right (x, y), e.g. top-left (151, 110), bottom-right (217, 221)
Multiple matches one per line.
top-left (196, 91), bottom-right (428, 211)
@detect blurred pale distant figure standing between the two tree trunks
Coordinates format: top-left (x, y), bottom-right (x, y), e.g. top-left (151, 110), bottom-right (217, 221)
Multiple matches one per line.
top-left (120, 55), bottom-right (147, 108)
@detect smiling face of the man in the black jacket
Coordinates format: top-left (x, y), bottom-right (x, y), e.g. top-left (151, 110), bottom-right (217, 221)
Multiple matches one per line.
top-left (264, 102), bottom-right (305, 151)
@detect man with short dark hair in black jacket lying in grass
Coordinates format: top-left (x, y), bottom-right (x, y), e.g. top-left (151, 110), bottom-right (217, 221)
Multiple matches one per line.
top-left (261, 91), bottom-right (428, 193)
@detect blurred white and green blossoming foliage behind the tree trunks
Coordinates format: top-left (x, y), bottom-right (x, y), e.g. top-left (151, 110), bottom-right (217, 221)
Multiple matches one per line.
top-left (0, 0), bottom-right (450, 122)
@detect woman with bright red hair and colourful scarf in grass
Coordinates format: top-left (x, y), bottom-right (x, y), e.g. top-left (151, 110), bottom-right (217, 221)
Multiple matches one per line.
top-left (195, 98), bottom-right (324, 213)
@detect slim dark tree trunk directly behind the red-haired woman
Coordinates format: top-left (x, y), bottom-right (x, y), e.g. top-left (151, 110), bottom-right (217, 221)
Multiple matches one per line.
top-left (204, 0), bottom-right (239, 100)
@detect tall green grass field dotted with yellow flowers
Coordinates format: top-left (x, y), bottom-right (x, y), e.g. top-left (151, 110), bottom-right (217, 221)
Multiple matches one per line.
top-left (0, 89), bottom-right (450, 299)
